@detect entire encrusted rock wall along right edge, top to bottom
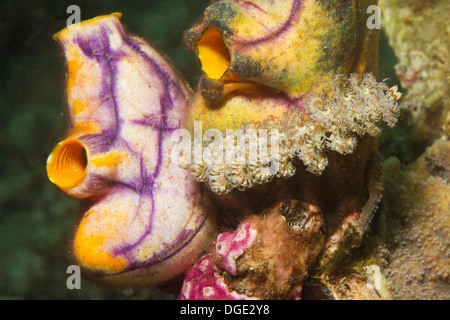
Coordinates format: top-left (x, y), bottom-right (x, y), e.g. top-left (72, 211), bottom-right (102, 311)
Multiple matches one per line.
top-left (374, 0), bottom-right (450, 299)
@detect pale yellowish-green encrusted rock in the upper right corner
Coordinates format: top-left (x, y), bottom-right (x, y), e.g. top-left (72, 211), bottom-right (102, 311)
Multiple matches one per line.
top-left (380, 0), bottom-right (450, 150)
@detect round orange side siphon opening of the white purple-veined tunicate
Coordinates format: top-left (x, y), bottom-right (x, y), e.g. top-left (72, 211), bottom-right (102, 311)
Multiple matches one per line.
top-left (47, 138), bottom-right (87, 190)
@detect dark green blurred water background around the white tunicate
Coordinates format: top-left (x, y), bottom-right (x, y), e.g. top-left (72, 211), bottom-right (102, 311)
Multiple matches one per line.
top-left (0, 0), bottom-right (400, 299)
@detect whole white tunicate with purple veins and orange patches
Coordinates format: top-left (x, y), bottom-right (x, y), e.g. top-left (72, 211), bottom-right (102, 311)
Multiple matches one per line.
top-left (47, 13), bottom-right (216, 286)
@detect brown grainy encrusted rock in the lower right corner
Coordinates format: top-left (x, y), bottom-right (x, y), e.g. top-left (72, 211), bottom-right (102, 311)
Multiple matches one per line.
top-left (380, 140), bottom-right (450, 299)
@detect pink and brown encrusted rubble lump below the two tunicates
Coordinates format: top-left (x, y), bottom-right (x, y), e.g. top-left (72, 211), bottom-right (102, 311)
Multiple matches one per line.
top-left (179, 201), bottom-right (323, 300)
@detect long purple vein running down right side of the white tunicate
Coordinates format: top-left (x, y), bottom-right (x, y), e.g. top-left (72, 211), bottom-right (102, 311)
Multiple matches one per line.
top-left (114, 33), bottom-right (191, 256)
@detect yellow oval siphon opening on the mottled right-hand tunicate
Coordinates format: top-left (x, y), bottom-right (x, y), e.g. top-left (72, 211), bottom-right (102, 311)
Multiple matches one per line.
top-left (197, 28), bottom-right (231, 80)
